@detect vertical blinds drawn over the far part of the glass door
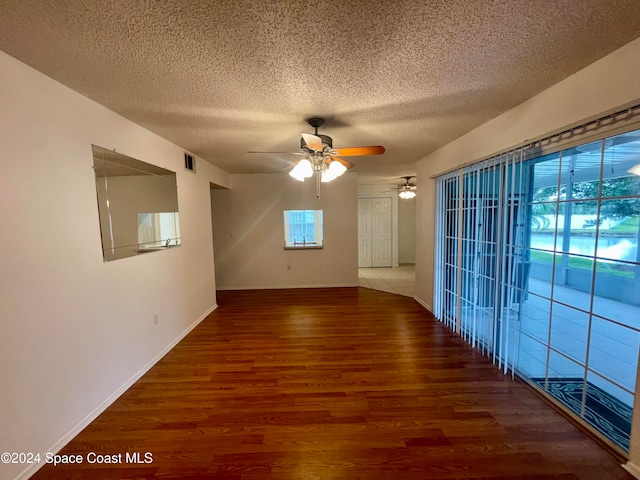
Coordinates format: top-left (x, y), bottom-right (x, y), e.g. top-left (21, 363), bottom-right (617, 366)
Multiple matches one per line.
top-left (434, 150), bottom-right (528, 372)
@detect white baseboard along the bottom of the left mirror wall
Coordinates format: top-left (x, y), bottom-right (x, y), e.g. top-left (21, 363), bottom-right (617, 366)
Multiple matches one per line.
top-left (15, 305), bottom-right (218, 480)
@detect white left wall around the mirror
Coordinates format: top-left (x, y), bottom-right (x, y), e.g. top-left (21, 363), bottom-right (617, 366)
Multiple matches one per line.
top-left (0, 52), bottom-right (229, 479)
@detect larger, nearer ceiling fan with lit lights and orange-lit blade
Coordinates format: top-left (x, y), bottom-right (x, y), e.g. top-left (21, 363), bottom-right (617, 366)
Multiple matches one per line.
top-left (247, 117), bottom-right (384, 198)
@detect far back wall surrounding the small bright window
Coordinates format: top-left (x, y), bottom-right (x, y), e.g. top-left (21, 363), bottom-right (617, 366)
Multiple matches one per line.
top-left (211, 173), bottom-right (358, 290)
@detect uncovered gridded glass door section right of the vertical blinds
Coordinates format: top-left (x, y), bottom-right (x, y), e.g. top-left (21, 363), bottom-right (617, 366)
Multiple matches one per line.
top-left (516, 132), bottom-right (640, 450)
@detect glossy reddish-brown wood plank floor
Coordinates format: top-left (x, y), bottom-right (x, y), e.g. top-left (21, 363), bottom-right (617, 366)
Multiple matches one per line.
top-left (34, 288), bottom-right (632, 480)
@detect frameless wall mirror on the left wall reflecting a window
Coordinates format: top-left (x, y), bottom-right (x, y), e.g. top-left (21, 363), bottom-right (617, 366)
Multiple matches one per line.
top-left (93, 145), bottom-right (180, 262)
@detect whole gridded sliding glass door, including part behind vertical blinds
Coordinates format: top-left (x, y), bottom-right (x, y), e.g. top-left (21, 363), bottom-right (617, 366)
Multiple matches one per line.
top-left (435, 126), bottom-right (640, 450)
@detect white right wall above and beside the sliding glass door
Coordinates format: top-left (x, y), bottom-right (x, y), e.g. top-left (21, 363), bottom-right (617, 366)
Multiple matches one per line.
top-left (415, 39), bottom-right (640, 309)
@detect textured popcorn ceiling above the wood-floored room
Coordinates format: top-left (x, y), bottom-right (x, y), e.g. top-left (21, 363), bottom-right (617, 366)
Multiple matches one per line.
top-left (0, 0), bottom-right (640, 183)
